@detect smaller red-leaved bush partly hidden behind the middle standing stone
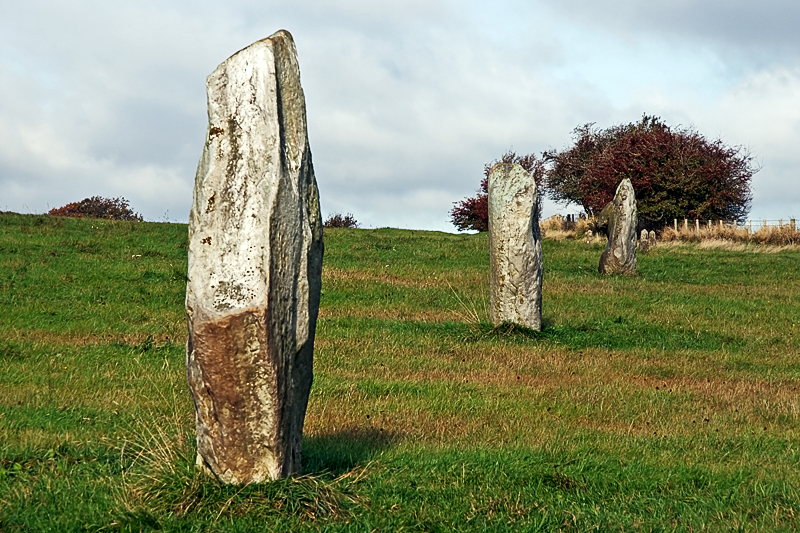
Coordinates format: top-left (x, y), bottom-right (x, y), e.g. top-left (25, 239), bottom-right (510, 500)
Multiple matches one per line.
top-left (450, 150), bottom-right (544, 231)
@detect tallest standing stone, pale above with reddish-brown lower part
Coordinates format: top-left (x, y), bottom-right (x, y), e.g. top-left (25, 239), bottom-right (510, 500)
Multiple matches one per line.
top-left (186, 31), bottom-right (323, 484)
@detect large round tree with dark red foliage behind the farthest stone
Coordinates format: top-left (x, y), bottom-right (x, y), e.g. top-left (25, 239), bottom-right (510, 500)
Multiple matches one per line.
top-left (543, 115), bottom-right (759, 227)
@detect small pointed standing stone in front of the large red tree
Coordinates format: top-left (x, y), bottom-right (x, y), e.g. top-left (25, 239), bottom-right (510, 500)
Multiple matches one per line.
top-left (598, 178), bottom-right (637, 274)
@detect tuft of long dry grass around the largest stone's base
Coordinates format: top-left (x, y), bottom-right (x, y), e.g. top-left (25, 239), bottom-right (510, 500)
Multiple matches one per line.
top-left (116, 412), bottom-right (370, 527)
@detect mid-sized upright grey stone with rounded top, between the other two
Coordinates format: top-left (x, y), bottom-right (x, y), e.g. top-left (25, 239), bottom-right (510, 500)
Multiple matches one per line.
top-left (489, 163), bottom-right (542, 331)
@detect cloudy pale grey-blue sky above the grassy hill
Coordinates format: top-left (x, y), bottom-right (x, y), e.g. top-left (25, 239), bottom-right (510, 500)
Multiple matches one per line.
top-left (0, 0), bottom-right (800, 232)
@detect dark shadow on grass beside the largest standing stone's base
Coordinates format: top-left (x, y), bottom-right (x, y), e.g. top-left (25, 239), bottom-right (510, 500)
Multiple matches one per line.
top-left (303, 426), bottom-right (400, 476)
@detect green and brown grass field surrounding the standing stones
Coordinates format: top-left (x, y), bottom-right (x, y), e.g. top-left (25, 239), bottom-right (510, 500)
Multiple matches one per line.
top-left (0, 213), bottom-right (800, 532)
